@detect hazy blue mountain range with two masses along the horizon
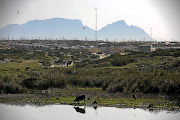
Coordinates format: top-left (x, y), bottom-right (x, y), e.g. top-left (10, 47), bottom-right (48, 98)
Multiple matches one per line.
top-left (0, 18), bottom-right (151, 40)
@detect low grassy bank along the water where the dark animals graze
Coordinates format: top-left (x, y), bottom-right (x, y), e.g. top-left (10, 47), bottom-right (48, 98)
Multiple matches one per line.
top-left (0, 88), bottom-right (180, 109)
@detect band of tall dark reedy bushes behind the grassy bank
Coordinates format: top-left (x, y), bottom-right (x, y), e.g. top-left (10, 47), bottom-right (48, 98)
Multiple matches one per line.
top-left (0, 68), bottom-right (180, 95)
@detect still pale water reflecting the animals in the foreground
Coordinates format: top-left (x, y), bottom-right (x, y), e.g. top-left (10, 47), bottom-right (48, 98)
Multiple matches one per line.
top-left (0, 103), bottom-right (180, 120)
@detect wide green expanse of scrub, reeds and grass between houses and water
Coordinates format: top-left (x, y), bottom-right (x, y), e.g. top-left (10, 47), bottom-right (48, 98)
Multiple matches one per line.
top-left (0, 49), bottom-right (180, 106)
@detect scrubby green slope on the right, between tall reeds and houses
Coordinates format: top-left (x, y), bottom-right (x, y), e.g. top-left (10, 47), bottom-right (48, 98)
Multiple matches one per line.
top-left (77, 50), bottom-right (180, 69)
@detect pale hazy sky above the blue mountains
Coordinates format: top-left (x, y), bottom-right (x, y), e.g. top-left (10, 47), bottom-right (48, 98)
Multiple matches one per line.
top-left (0, 0), bottom-right (180, 40)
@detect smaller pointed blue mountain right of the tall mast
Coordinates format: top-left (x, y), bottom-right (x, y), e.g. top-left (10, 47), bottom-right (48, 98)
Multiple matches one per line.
top-left (98, 20), bottom-right (150, 40)
